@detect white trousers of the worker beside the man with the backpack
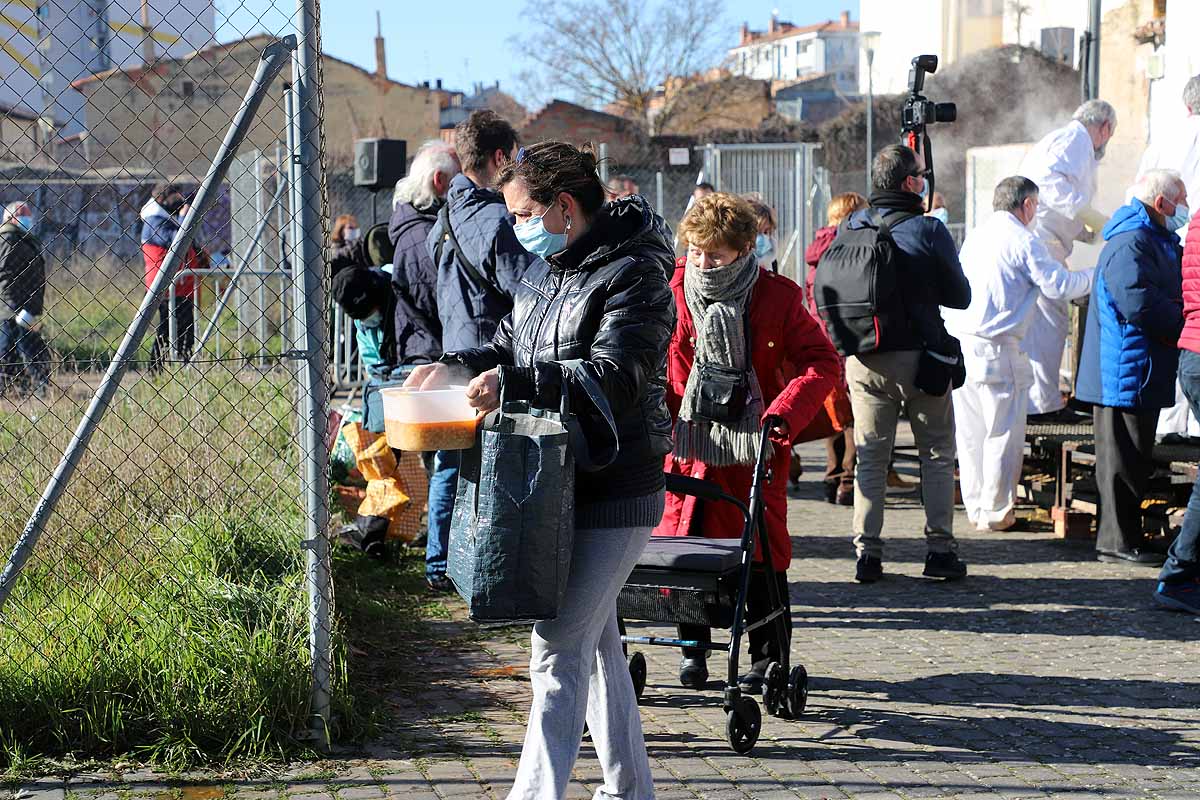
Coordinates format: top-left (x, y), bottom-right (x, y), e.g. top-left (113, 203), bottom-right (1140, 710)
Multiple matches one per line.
top-left (953, 336), bottom-right (1033, 530)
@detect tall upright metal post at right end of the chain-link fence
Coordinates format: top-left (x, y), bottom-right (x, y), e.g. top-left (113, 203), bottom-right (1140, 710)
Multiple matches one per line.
top-left (292, 0), bottom-right (332, 746)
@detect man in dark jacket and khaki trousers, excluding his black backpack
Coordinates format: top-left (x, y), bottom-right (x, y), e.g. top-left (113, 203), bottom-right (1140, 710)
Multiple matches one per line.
top-left (846, 145), bottom-right (971, 583)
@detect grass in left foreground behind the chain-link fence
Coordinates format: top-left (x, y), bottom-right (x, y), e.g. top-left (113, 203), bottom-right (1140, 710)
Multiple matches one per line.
top-left (0, 365), bottom-right (357, 772)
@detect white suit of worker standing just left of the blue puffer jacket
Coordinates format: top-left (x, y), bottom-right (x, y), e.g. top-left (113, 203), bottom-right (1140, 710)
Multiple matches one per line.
top-left (1018, 120), bottom-right (1098, 414)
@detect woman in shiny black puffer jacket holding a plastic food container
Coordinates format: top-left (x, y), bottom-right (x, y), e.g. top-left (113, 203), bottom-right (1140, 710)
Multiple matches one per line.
top-left (409, 142), bottom-right (676, 800)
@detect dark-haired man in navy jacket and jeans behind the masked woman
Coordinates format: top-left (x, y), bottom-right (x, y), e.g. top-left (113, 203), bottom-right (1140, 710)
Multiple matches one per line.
top-left (425, 110), bottom-right (538, 591)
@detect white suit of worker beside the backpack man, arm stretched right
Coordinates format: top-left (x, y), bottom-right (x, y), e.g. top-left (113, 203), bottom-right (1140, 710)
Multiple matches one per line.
top-left (942, 211), bottom-right (1094, 530)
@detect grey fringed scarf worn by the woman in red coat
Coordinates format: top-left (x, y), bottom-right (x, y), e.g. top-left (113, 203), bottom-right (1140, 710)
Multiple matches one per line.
top-left (674, 253), bottom-right (763, 467)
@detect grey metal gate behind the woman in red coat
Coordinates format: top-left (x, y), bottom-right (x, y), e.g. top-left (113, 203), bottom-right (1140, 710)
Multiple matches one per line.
top-left (697, 142), bottom-right (829, 285)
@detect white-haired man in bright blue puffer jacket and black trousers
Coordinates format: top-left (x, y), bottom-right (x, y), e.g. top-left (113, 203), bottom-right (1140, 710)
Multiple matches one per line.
top-left (1075, 169), bottom-right (1188, 566)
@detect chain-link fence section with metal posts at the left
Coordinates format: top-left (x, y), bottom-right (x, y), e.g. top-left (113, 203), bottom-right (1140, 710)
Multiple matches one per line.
top-left (0, 0), bottom-right (338, 769)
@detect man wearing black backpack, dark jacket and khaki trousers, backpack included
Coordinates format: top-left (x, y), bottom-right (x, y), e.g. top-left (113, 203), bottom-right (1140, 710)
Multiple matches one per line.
top-left (814, 145), bottom-right (971, 583)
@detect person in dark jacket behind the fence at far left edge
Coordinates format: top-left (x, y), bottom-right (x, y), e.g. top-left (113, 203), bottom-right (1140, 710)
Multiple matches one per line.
top-left (0, 200), bottom-right (49, 391)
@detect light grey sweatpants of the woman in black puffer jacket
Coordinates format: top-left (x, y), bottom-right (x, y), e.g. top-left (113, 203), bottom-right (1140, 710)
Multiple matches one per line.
top-left (509, 528), bottom-right (654, 800)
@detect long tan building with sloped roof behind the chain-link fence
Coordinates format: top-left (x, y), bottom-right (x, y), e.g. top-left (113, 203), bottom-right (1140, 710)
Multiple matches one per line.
top-left (72, 36), bottom-right (439, 176)
